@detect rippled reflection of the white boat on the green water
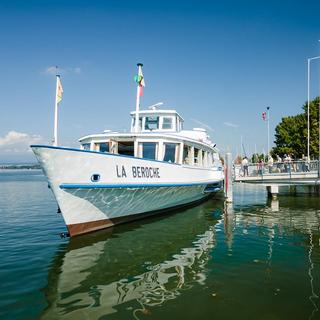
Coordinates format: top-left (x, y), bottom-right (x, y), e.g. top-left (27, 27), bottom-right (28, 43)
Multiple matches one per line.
top-left (42, 200), bottom-right (224, 319)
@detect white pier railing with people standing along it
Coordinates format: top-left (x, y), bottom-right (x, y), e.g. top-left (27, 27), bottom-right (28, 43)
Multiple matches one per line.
top-left (233, 160), bottom-right (319, 180)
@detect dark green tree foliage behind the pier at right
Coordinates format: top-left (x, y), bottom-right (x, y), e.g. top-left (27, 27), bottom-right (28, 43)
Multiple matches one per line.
top-left (272, 97), bottom-right (320, 158)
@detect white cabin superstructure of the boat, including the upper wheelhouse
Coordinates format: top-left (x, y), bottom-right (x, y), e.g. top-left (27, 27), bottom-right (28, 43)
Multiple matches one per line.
top-left (79, 108), bottom-right (220, 168)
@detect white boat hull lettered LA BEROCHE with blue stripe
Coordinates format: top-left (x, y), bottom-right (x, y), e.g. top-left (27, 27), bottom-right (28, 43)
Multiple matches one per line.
top-left (32, 145), bottom-right (223, 236)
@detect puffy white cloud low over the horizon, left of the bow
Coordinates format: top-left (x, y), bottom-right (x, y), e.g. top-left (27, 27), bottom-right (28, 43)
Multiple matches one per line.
top-left (0, 130), bottom-right (43, 153)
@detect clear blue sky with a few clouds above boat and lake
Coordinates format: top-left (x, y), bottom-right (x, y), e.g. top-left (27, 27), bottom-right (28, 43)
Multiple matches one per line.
top-left (0, 0), bottom-right (320, 162)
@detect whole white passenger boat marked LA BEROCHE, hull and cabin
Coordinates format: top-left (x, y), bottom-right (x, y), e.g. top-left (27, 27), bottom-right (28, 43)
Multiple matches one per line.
top-left (31, 65), bottom-right (224, 236)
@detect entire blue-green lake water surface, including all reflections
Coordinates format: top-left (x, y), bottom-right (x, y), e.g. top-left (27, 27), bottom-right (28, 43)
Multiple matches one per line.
top-left (0, 171), bottom-right (320, 320)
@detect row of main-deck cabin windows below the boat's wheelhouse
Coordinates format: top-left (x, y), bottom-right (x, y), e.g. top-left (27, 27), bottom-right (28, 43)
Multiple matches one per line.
top-left (82, 141), bottom-right (218, 167)
